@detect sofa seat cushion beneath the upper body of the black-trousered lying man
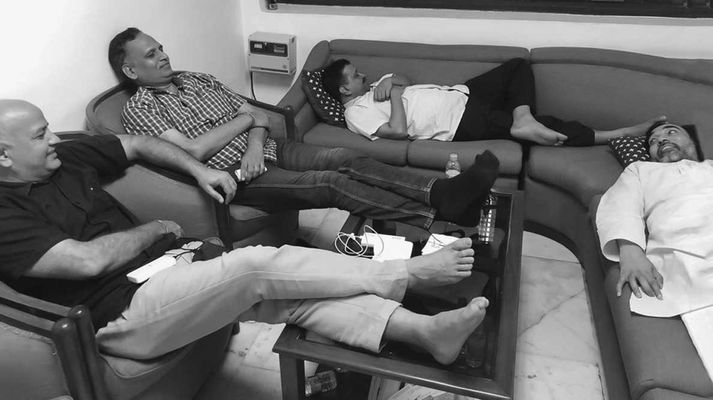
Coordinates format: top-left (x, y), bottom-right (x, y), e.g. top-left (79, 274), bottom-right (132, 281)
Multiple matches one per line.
top-left (303, 123), bottom-right (406, 166)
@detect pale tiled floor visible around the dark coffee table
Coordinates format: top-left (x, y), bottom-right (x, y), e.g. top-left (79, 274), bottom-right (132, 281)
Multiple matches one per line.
top-left (199, 210), bottom-right (606, 400)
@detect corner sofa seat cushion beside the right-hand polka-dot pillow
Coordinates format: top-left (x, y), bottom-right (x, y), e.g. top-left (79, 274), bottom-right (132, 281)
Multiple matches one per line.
top-left (527, 146), bottom-right (623, 207)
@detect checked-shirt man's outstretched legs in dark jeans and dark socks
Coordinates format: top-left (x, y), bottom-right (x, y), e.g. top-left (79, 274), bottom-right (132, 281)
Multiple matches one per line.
top-left (233, 141), bottom-right (499, 229)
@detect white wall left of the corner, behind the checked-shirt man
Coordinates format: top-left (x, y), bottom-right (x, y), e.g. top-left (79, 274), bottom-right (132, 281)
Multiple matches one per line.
top-left (0, 0), bottom-right (246, 131)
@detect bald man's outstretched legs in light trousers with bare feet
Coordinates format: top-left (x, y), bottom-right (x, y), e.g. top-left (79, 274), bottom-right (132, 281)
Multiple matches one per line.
top-left (97, 239), bottom-right (488, 363)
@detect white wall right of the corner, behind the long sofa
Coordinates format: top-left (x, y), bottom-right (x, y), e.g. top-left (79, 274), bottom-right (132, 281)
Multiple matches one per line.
top-left (241, 0), bottom-right (713, 103)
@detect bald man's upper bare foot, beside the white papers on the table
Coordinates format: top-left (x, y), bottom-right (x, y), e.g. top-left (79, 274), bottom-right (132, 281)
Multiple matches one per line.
top-left (406, 238), bottom-right (474, 290)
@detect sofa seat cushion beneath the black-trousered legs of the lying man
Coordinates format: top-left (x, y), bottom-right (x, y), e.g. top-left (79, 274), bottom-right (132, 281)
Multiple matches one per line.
top-left (408, 139), bottom-right (522, 176)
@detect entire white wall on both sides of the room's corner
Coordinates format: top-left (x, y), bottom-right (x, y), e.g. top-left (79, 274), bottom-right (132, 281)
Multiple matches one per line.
top-left (0, 0), bottom-right (713, 131)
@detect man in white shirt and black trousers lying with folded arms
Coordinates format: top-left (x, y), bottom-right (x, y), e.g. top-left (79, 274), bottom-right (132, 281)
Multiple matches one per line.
top-left (322, 58), bottom-right (662, 146)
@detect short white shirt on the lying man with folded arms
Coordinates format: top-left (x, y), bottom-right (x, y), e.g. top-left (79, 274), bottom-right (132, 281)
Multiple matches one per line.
top-left (344, 74), bottom-right (469, 141)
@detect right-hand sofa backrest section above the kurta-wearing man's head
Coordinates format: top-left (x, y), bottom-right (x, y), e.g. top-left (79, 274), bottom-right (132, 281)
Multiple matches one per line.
top-left (530, 47), bottom-right (713, 158)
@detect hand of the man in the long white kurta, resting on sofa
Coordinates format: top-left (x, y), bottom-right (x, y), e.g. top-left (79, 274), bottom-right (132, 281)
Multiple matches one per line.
top-left (616, 240), bottom-right (663, 300)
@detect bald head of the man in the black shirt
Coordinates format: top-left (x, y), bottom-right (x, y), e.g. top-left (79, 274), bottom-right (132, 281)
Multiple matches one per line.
top-left (0, 99), bottom-right (62, 183)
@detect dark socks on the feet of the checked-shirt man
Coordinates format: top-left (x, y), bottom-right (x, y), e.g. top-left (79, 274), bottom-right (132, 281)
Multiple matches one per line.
top-left (431, 150), bottom-right (500, 226)
